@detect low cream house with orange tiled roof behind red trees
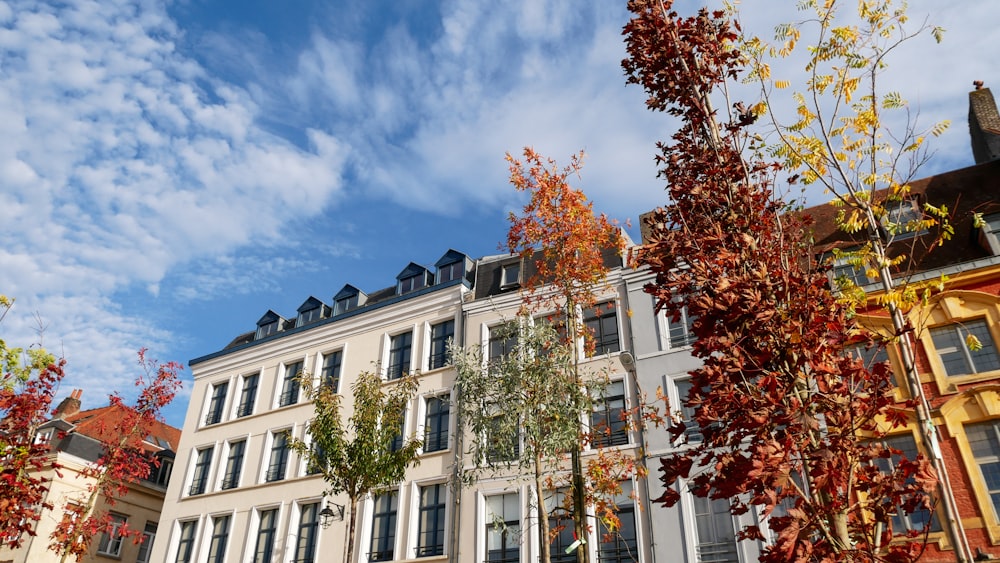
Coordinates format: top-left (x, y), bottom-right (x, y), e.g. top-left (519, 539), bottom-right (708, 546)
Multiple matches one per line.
top-left (0, 389), bottom-right (180, 563)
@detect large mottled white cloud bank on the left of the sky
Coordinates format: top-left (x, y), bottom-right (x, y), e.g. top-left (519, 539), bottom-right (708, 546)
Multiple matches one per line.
top-left (0, 0), bottom-right (347, 410)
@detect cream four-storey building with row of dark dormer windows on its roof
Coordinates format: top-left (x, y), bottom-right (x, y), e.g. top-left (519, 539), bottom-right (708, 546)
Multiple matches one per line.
top-left (153, 251), bottom-right (475, 563)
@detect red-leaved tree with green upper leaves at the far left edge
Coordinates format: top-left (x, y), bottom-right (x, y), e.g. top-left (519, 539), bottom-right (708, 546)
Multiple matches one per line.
top-left (0, 295), bottom-right (65, 548)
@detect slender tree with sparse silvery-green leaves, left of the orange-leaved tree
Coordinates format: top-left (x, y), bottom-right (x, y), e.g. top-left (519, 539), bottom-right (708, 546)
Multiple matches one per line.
top-left (450, 316), bottom-right (589, 563)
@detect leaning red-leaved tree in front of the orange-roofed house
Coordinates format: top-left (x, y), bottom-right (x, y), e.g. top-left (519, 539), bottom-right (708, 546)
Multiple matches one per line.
top-left (49, 350), bottom-right (182, 562)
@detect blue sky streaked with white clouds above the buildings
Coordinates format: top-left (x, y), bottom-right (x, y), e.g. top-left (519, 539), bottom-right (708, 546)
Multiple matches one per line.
top-left (0, 0), bottom-right (1000, 425)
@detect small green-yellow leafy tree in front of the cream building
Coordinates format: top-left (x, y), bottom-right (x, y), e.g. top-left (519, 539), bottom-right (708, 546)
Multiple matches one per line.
top-left (291, 371), bottom-right (422, 561)
